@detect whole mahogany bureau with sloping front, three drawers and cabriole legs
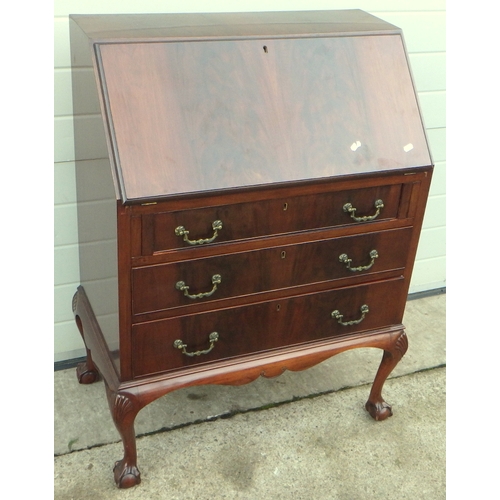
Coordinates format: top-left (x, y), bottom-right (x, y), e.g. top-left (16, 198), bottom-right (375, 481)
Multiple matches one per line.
top-left (70, 10), bottom-right (433, 488)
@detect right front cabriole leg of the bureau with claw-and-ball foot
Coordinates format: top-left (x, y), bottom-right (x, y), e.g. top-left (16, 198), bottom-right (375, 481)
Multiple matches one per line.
top-left (365, 332), bottom-right (408, 420)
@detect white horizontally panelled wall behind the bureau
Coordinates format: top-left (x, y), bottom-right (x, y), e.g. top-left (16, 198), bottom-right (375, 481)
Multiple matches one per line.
top-left (54, 0), bottom-right (446, 361)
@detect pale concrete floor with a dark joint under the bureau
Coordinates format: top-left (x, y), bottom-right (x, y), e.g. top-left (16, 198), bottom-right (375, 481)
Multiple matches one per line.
top-left (54, 294), bottom-right (446, 500)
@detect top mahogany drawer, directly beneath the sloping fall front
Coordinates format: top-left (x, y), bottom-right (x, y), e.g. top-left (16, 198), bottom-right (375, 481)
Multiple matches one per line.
top-left (141, 184), bottom-right (402, 255)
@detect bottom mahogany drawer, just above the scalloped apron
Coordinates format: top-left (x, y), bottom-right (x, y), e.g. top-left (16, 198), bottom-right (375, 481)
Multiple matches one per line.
top-left (132, 278), bottom-right (406, 377)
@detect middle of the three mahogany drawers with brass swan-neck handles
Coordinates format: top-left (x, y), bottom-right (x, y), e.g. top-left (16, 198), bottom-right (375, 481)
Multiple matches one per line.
top-left (132, 228), bottom-right (412, 315)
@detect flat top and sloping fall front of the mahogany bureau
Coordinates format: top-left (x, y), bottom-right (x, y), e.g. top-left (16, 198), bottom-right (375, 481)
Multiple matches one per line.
top-left (73, 11), bottom-right (432, 202)
